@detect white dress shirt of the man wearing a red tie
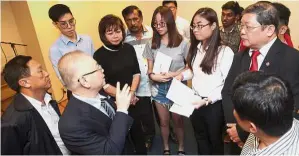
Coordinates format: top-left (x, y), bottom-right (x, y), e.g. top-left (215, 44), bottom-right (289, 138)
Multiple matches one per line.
top-left (249, 37), bottom-right (277, 69)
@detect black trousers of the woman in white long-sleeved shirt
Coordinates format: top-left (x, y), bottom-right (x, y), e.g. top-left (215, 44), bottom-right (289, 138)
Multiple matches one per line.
top-left (191, 101), bottom-right (224, 155)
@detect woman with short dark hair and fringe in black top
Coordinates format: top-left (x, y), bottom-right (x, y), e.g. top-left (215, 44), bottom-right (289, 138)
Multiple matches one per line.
top-left (93, 14), bottom-right (147, 155)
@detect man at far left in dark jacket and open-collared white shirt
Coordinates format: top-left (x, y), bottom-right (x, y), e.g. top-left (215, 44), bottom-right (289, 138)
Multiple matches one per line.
top-left (1, 55), bottom-right (69, 155)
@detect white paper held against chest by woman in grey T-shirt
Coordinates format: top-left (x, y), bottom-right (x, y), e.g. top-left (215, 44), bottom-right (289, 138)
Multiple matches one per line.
top-left (153, 51), bottom-right (172, 74)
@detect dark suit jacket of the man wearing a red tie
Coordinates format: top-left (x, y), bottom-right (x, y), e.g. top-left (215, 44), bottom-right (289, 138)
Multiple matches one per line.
top-left (222, 38), bottom-right (299, 140)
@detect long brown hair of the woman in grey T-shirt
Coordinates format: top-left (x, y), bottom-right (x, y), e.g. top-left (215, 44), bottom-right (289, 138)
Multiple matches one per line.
top-left (151, 6), bottom-right (183, 49)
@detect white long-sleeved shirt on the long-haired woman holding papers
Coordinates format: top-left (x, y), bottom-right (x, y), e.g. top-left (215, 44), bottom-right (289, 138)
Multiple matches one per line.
top-left (183, 43), bottom-right (234, 104)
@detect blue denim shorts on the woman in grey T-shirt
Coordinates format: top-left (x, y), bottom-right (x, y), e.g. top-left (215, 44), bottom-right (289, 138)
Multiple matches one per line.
top-left (151, 80), bottom-right (173, 109)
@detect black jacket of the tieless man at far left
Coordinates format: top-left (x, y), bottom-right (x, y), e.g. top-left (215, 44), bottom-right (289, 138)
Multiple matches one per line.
top-left (1, 94), bottom-right (62, 155)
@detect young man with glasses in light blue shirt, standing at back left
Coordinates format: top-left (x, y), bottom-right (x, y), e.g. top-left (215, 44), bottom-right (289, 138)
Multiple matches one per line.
top-left (49, 4), bottom-right (94, 99)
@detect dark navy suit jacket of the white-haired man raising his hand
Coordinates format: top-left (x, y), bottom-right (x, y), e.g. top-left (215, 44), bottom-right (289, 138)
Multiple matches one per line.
top-left (59, 96), bottom-right (133, 155)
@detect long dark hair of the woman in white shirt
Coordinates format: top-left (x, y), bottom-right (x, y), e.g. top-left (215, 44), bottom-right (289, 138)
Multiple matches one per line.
top-left (187, 8), bottom-right (221, 74)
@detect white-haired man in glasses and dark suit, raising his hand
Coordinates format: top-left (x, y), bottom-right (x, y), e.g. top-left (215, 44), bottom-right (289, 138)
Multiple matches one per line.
top-left (58, 51), bottom-right (133, 155)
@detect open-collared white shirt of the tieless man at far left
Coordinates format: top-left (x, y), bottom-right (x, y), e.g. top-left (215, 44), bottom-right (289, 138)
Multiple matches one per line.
top-left (22, 94), bottom-right (70, 155)
